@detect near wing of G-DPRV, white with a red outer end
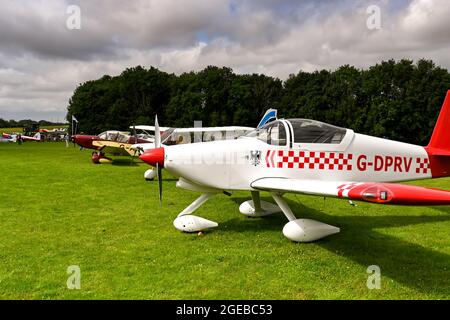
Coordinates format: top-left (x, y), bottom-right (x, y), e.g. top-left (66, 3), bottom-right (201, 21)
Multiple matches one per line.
top-left (251, 178), bottom-right (450, 205)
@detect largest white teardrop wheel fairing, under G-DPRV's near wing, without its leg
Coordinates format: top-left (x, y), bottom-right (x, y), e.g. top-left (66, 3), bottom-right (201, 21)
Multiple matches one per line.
top-left (283, 219), bottom-right (340, 242)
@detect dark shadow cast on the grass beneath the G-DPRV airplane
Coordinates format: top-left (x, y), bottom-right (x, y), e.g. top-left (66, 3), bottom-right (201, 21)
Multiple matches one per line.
top-left (227, 198), bottom-right (450, 299)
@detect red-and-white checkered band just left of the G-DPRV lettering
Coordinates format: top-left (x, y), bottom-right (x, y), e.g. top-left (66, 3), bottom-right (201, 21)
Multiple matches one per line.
top-left (266, 150), bottom-right (353, 171)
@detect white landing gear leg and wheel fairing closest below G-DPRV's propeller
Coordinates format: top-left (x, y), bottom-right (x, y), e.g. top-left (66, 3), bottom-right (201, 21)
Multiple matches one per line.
top-left (173, 193), bottom-right (218, 232)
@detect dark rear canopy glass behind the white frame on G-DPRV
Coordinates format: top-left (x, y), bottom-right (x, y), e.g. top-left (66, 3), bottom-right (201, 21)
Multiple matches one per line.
top-left (288, 119), bottom-right (347, 144)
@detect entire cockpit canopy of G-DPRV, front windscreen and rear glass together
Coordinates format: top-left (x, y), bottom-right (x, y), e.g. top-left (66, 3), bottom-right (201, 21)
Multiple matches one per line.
top-left (245, 119), bottom-right (347, 146)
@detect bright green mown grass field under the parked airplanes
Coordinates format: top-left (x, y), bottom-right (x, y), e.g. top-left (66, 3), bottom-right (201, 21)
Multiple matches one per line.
top-left (0, 143), bottom-right (450, 299)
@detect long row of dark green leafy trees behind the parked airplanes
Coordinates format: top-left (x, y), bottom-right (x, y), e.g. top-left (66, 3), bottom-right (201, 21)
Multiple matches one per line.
top-left (67, 59), bottom-right (450, 145)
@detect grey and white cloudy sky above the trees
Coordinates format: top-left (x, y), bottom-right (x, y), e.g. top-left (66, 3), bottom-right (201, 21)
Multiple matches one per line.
top-left (0, 0), bottom-right (450, 121)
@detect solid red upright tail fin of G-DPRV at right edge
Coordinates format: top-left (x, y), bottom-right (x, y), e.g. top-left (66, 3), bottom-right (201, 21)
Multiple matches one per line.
top-left (426, 90), bottom-right (450, 156)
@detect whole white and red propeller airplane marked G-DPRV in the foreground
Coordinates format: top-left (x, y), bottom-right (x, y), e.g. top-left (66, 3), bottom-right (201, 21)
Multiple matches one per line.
top-left (140, 90), bottom-right (450, 242)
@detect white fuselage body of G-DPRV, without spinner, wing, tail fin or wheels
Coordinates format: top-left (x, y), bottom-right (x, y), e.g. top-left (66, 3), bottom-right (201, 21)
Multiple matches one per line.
top-left (164, 120), bottom-right (432, 190)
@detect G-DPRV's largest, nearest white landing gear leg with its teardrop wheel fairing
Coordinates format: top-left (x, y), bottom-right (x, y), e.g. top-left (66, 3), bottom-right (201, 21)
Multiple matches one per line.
top-left (271, 192), bottom-right (340, 242)
